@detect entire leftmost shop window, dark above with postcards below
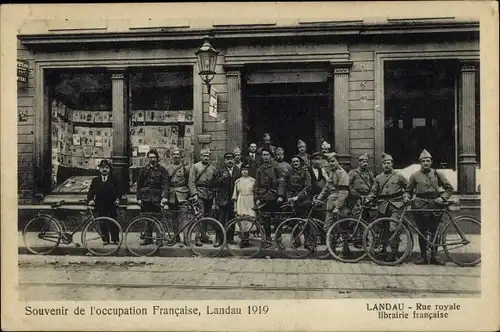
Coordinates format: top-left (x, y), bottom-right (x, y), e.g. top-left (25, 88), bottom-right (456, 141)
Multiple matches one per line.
top-left (46, 69), bottom-right (113, 193)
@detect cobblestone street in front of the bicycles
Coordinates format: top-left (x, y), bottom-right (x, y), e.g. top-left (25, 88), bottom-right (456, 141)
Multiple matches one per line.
top-left (19, 255), bottom-right (481, 301)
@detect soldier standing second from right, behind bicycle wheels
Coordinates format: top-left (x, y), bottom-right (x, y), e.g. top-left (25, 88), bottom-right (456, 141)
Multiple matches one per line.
top-left (367, 154), bottom-right (408, 261)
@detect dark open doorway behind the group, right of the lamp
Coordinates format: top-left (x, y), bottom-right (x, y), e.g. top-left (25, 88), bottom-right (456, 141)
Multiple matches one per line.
top-left (245, 82), bottom-right (333, 160)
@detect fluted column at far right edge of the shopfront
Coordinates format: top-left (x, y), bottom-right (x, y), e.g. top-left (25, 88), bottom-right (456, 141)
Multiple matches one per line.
top-left (458, 62), bottom-right (477, 194)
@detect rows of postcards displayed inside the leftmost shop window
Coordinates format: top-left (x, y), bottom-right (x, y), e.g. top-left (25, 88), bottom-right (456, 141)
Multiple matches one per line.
top-left (51, 99), bottom-right (113, 192)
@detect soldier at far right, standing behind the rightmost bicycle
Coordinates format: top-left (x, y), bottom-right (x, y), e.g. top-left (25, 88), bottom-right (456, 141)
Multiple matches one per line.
top-left (404, 149), bottom-right (453, 265)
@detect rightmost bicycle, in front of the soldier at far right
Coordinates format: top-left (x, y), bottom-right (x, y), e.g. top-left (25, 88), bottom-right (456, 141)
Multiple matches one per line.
top-left (363, 198), bottom-right (481, 266)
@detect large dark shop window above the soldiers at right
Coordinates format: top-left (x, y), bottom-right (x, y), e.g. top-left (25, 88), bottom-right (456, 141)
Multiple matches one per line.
top-left (384, 60), bottom-right (457, 169)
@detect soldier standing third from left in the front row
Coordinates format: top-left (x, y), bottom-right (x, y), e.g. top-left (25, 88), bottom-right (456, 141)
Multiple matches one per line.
top-left (167, 148), bottom-right (192, 246)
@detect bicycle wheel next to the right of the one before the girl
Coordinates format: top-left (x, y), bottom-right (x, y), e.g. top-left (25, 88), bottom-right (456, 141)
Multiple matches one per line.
top-left (275, 218), bottom-right (316, 258)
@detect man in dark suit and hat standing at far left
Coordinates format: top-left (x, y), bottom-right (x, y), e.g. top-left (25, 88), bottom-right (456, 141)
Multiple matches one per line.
top-left (87, 159), bottom-right (122, 245)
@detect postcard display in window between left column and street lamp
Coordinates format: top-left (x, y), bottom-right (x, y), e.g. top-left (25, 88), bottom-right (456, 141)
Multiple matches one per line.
top-left (129, 110), bottom-right (194, 191)
